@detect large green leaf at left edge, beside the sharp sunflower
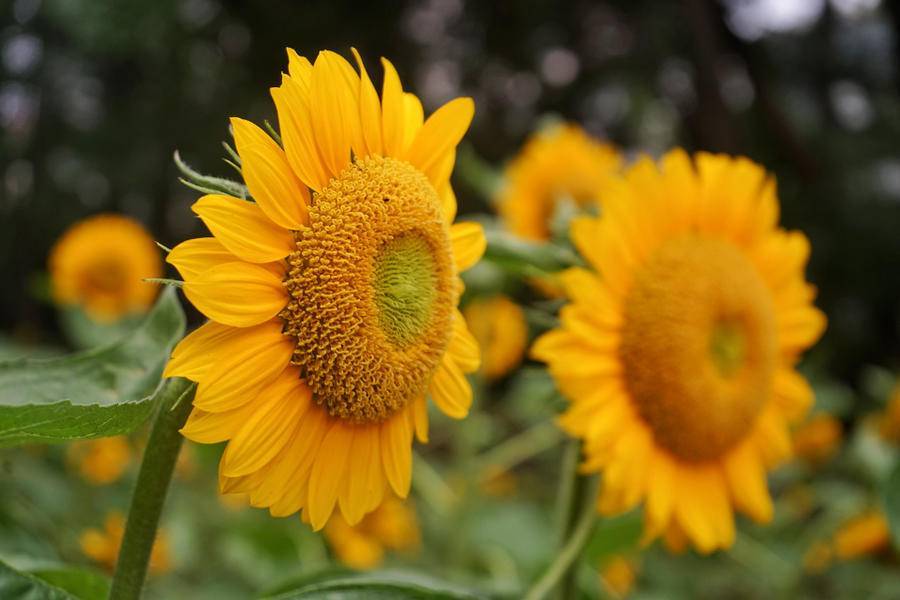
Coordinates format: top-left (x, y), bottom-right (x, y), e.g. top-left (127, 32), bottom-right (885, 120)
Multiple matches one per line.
top-left (0, 289), bottom-right (185, 446)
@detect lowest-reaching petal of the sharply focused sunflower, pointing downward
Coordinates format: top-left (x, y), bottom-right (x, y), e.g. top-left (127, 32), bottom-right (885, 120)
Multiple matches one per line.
top-left (307, 422), bottom-right (354, 531)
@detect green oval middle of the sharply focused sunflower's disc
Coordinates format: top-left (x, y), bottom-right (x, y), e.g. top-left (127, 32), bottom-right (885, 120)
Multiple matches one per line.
top-left (374, 235), bottom-right (437, 346)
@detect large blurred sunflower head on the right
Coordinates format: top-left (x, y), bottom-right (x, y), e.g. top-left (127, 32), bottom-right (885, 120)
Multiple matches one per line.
top-left (533, 150), bottom-right (825, 552)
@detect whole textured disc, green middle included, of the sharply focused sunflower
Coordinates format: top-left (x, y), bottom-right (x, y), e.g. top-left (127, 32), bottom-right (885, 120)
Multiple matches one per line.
top-left (281, 157), bottom-right (457, 424)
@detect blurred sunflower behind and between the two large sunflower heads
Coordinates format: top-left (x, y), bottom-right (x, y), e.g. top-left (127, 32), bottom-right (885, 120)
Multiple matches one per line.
top-left (497, 123), bottom-right (622, 241)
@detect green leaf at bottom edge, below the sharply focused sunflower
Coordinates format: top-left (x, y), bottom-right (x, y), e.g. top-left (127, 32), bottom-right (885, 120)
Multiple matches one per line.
top-left (268, 571), bottom-right (489, 600)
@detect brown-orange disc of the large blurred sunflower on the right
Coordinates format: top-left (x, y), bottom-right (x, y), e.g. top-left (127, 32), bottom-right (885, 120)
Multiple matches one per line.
top-left (619, 235), bottom-right (776, 462)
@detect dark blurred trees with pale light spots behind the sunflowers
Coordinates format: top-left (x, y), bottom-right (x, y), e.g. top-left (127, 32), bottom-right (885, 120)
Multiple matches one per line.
top-left (0, 0), bottom-right (900, 384)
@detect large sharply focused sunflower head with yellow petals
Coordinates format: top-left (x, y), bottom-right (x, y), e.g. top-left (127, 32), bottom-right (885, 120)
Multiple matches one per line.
top-left (166, 50), bottom-right (485, 530)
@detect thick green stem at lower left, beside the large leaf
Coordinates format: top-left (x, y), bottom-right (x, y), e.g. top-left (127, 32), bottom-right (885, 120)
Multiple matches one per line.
top-left (109, 379), bottom-right (195, 600)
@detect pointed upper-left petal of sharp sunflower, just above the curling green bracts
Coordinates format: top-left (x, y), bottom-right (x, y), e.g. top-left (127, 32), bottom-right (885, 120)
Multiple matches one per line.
top-left (231, 118), bottom-right (309, 230)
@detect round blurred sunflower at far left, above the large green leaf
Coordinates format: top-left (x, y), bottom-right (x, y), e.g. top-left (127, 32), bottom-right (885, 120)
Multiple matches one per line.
top-left (49, 214), bottom-right (163, 322)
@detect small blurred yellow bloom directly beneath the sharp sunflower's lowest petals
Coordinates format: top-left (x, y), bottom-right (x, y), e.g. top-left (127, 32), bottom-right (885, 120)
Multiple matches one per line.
top-left (324, 496), bottom-right (420, 570)
